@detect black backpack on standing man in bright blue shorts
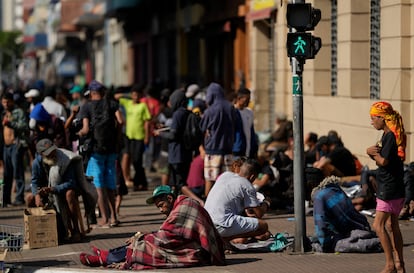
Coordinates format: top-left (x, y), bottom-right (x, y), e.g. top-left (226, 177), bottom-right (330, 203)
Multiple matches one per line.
top-left (90, 99), bottom-right (116, 154)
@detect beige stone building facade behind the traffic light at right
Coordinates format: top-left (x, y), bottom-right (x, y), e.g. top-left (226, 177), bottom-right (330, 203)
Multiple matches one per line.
top-left (258, 0), bottom-right (414, 167)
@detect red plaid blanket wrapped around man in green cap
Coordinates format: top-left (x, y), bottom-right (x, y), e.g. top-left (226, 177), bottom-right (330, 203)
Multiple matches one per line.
top-left (123, 195), bottom-right (225, 270)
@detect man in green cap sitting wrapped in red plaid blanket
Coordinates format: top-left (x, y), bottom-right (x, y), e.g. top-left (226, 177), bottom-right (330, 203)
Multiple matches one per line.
top-left (80, 185), bottom-right (225, 270)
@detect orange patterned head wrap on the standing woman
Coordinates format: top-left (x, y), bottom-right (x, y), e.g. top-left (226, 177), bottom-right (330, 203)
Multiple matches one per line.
top-left (369, 101), bottom-right (407, 161)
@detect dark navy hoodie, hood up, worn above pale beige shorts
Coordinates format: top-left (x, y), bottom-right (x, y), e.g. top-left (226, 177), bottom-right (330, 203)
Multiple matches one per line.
top-left (200, 82), bottom-right (236, 155)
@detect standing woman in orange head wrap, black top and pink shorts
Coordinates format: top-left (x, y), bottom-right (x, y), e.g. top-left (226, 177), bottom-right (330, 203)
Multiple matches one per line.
top-left (367, 101), bottom-right (406, 273)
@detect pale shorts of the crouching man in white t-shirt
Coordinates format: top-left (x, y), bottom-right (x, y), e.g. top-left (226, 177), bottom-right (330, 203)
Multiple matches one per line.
top-left (216, 215), bottom-right (259, 237)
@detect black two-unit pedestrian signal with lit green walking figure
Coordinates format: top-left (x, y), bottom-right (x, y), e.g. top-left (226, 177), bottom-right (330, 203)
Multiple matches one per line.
top-left (286, 3), bottom-right (322, 60)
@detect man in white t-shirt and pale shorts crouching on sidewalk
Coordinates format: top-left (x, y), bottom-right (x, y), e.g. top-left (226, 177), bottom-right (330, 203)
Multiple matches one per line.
top-left (204, 159), bottom-right (270, 243)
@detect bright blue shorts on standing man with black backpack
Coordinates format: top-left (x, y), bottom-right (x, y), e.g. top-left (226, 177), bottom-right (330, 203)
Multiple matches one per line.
top-left (86, 153), bottom-right (117, 190)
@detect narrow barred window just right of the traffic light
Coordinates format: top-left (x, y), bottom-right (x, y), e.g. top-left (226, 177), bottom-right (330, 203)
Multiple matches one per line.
top-left (331, 0), bottom-right (338, 96)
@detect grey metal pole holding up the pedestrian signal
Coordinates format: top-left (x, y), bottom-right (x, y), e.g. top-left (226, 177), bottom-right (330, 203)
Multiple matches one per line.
top-left (291, 0), bottom-right (306, 253)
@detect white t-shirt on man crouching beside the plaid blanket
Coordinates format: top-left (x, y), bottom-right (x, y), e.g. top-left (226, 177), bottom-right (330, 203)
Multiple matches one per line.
top-left (204, 172), bottom-right (260, 227)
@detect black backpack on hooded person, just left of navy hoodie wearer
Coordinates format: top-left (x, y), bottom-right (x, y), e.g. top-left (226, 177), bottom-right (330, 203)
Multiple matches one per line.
top-left (183, 111), bottom-right (204, 151)
